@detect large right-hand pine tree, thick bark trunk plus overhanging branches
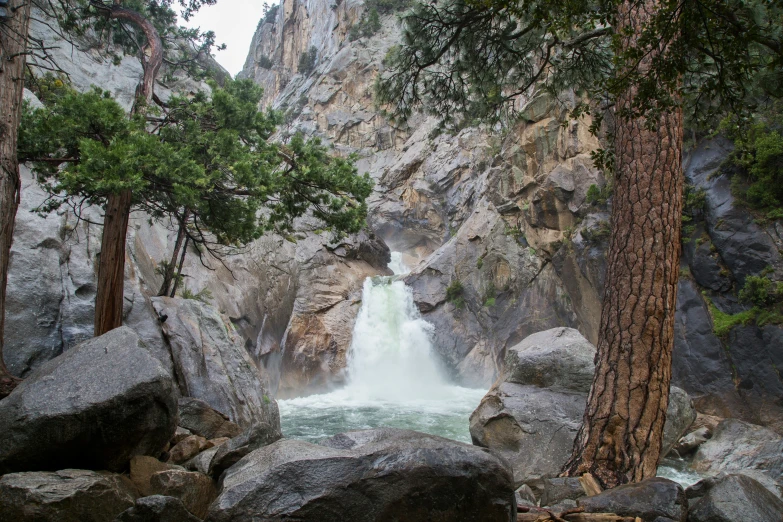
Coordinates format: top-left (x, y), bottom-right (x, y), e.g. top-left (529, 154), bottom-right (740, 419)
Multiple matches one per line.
top-left (377, 0), bottom-right (783, 487)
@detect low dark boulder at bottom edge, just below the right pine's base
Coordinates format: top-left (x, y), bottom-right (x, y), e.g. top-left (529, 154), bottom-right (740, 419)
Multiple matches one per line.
top-left (577, 477), bottom-right (688, 522)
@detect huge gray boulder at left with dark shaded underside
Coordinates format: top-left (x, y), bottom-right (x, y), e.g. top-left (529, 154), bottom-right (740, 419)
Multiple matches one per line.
top-left (0, 327), bottom-right (177, 473)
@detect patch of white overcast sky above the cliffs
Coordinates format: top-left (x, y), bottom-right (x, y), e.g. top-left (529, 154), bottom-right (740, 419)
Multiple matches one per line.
top-left (180, 0), bottom-right (268, 76)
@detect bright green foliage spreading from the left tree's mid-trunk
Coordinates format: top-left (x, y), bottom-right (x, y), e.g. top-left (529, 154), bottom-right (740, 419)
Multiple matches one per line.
top-left (19, 80), bottom-right (372, 255)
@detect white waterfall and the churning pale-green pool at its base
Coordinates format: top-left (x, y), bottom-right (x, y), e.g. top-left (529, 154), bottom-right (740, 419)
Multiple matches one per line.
top-left (279, 252), bottom-right (486, 442)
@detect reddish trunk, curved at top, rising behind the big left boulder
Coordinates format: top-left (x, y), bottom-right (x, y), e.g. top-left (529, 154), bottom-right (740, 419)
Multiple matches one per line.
top-left (94, 5), bottom-right (163, 336)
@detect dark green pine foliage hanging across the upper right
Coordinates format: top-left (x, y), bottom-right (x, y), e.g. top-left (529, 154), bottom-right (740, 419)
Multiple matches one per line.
top-left (376, 0), bottom-right (783, 142)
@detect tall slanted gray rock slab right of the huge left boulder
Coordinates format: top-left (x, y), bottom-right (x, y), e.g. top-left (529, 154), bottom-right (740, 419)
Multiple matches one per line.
top-left (152, 297), bottom-right (280, 427)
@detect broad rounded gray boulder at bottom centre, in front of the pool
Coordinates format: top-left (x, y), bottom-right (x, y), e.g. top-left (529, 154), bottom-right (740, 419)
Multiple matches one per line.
top-left (206, 429), bottom-right (516, 522)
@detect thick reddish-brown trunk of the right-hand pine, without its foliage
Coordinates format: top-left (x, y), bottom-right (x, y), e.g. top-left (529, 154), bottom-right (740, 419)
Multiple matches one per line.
top-left (563, 1), bottom-right (683, 487)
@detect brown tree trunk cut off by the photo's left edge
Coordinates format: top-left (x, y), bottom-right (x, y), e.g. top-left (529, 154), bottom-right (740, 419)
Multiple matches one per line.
top-left (0, 0), bottom-right (30, 399)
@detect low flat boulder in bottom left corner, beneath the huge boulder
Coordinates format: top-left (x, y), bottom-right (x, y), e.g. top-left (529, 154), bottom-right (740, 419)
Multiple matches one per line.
top-left (0, 469), bottom-right (138, 522)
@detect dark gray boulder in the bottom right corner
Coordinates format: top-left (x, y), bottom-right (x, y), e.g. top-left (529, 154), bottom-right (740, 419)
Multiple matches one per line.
top-left (686, 475), bottom-right (783, 522)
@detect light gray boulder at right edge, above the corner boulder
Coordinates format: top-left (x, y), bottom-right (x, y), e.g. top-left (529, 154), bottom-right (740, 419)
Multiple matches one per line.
top-left (691, 419), bottom-right (783, 497)
